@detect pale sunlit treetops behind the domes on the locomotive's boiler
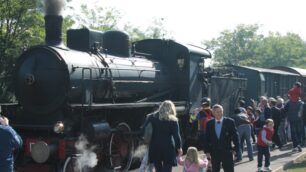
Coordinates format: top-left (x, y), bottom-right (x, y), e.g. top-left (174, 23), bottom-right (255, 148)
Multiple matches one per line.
top-left (68, 4), bottom-right (170, 42)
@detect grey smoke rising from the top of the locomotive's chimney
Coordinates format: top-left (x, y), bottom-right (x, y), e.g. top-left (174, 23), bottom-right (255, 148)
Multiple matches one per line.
top-left (45, 0), bottom-right (66, 15)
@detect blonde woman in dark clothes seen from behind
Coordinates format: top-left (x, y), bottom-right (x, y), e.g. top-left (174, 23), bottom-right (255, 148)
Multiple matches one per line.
top-left (149, 100), bottom-right (182, 172)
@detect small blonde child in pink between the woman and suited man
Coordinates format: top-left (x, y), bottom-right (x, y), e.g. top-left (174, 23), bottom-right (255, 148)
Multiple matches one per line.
top-left (177, 147), bottom-right (208, 172)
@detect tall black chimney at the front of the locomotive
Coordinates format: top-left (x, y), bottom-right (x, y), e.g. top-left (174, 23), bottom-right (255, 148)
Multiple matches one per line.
top-left (45, 15), bottom-right (63, 45)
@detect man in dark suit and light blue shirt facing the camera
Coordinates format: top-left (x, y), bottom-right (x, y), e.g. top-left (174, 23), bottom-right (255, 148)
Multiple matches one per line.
top-left (204, 104), bottom-right (239, 172)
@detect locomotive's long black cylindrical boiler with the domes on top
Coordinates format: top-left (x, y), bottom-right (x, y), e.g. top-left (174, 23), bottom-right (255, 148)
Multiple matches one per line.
top-left (15, 16), bottom-right (173, 118)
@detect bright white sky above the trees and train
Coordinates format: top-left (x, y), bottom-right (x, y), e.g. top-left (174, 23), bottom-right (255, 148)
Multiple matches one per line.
top-left (68, 0), bottom-right (306, 45)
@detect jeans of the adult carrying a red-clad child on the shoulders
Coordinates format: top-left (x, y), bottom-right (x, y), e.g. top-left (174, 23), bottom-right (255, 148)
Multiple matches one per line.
top-left (290, 119), bottom-right (303, 148)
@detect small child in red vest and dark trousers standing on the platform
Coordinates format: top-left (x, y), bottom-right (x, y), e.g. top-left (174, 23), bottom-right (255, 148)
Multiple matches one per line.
top-left (257, 119), bottom-right (274, 172)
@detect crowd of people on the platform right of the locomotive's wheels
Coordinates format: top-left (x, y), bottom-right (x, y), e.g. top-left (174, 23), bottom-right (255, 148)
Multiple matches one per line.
top-left (140, 82), bottom-right (306, 172)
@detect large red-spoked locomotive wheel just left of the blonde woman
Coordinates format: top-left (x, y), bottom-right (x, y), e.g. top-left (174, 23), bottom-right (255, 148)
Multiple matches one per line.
top-left (109, 123), bottom-right (134, 171)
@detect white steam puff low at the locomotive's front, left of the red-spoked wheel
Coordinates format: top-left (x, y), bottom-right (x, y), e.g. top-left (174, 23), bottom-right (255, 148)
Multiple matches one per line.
top-left (75, 135), bottom-right (98, 170)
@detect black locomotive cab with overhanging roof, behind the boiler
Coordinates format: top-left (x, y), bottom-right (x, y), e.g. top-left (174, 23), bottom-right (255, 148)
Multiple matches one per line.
top-left (133, 39), bottom-right (211, 111)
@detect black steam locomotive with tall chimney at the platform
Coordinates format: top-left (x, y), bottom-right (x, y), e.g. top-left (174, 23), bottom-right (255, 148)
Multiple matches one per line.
top-left (2, 15), bottom-right (211, 172)
